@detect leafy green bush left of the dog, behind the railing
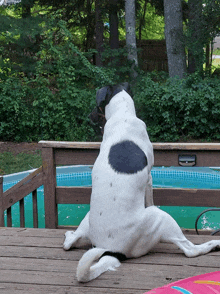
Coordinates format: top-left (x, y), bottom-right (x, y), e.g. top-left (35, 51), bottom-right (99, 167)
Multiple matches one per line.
top-left (0, 74), bottom-right (98, 141)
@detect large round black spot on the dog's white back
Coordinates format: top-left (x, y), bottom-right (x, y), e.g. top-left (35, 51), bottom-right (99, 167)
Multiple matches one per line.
top-left (108, 140), bottom-right (147, 174)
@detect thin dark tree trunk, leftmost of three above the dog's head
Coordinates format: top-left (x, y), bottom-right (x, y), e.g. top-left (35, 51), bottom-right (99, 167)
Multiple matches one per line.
top-left (95, 0), bottom-right (104, 66)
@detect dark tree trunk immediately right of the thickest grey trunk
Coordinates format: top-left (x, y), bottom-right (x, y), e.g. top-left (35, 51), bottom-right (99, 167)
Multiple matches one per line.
top-left (188, 0), bottom-right (203, 73)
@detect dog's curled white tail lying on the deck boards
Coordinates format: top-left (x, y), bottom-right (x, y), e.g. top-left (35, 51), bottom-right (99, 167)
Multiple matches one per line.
top-left (76, 248), bottom-right (121, 282)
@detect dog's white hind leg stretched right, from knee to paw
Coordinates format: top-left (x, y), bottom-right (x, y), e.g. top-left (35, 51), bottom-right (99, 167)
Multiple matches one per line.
top-left (161, 209), bottom-right (220, 257)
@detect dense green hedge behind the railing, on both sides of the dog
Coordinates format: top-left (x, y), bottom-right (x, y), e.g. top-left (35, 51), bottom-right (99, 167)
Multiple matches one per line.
top-left (0, 70), bottom-right (220, 142)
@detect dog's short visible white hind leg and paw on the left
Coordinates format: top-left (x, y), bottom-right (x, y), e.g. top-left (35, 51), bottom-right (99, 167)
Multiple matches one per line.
top-left (63, 212), bottom-right (91, 250)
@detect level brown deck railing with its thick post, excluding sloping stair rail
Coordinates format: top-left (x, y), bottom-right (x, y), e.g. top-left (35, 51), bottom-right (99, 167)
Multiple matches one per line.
top-left (39, 141), bottom-right (220, 228)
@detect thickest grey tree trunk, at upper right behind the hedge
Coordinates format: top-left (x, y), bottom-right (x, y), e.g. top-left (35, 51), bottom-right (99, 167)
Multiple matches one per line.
top-left (164, 0), bottom-right (186, 78)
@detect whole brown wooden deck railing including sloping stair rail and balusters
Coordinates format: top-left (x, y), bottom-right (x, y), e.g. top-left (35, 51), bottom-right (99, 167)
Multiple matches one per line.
top-left (0, 141), bottom-right (220, 228)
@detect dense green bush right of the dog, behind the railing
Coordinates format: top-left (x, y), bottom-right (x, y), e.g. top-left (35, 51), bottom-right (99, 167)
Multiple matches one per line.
top-left (134, 75), bottom-right (220, 141)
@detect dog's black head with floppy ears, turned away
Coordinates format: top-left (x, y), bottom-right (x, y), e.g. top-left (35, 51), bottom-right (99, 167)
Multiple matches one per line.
top-left (89, 83), bottom-right (131, 131)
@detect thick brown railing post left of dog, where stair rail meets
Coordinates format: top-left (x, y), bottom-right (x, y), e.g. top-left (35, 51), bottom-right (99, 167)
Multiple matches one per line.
top-left (42, 147), bottom-right (58, 229)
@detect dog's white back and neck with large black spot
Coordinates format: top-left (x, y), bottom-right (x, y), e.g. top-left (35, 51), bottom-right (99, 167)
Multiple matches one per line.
top-left (87, 91), bottom-right (153, 252)
